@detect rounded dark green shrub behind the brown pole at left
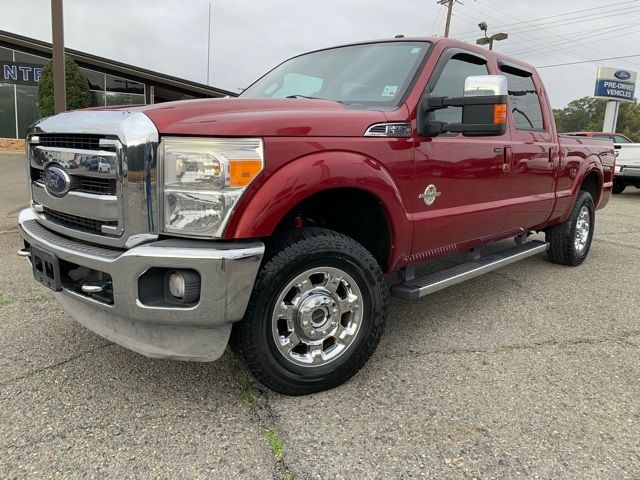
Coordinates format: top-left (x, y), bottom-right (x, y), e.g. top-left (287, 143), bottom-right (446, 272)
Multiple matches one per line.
top-left (38, 55), bottom-right (91, 117)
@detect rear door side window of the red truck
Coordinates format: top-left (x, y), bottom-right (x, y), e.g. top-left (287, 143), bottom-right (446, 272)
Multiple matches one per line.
top-left (502, 67), bottom-right (544, 130)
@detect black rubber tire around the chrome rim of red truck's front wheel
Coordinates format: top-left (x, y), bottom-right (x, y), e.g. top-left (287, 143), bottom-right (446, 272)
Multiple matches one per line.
top-left (231, 228), bottom-right (389, 395)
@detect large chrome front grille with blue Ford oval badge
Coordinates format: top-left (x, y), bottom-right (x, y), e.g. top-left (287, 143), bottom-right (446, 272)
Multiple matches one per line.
top-left (27, 109), bottom-right (159, 248)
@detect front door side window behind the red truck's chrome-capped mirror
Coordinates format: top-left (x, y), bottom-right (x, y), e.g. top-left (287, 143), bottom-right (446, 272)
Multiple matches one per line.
top-left (431, 54), bottom-right (489, 123)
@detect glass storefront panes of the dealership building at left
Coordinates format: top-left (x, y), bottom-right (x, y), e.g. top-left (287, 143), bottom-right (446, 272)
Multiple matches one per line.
top-left (0, 47), bottom-right (146, 138)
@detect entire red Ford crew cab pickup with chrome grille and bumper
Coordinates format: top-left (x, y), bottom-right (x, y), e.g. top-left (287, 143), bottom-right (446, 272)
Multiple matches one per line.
top-left (19, 38), bottom-right (615, 395)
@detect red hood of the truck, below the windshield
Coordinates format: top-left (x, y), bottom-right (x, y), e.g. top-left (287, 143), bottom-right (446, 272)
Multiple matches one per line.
top-left (130, 98), bottom-right (386, 137)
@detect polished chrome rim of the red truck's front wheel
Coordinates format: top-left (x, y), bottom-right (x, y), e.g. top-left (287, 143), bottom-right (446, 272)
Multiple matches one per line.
top-left (271, 267), bottom-right (363, 367)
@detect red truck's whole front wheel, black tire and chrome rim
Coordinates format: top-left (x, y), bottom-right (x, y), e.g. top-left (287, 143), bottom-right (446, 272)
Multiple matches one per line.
top-left (232, 228), bottom-right (388, 395)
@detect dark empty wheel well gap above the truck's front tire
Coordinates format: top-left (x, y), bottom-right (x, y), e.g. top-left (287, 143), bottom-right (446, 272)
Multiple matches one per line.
top-left (274, 188), bottom-right (391, 271)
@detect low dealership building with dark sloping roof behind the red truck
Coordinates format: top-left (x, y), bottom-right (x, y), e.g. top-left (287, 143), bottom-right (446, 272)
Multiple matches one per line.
top-left (0, 30), bottom-right (236, 138)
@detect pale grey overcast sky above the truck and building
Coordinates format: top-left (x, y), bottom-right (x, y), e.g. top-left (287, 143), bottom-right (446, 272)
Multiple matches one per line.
top-left (0, 0), bottom-right (640, 107)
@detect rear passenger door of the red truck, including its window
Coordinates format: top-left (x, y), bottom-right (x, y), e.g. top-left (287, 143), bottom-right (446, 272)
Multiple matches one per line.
top-left (498, 62), bottom-right (559, 230)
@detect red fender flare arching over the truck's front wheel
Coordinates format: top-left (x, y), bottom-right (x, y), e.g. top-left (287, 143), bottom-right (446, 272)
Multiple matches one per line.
top-left (224, 150), bottom-right (413, 269)
